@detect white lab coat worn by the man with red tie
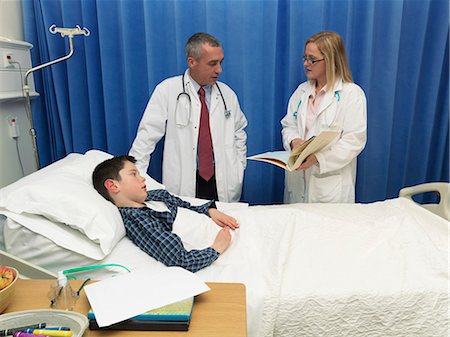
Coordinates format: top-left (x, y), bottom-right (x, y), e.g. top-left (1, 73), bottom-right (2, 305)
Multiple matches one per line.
top-left (130, 71), bottom-right (247, 202)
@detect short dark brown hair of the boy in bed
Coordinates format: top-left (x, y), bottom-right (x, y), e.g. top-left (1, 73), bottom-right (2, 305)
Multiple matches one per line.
top-left (92, 156), bottom-right (136, 203)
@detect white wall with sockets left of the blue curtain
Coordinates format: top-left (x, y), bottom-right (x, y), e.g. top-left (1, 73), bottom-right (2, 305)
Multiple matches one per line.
top-left (0, 0), bottom-right (37, 187)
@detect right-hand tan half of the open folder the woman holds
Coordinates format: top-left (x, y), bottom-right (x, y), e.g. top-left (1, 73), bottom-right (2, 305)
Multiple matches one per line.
top-left (288, 131), bottom-right (341, 170)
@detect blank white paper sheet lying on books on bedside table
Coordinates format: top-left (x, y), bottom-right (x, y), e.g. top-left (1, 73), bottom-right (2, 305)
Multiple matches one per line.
top-left (84, 267), bottom-right (210, 327)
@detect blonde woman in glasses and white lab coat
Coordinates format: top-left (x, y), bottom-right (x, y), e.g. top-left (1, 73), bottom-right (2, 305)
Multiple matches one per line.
top-left (281, 31), bottom-right (367, 203)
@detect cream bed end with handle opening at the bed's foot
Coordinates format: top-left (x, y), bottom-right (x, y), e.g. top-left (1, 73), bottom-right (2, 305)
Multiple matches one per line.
top-left (399, 182), bottom-right (450, 220)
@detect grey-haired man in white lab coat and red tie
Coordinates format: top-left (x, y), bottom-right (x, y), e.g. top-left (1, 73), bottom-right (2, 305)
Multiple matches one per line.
top-left (130, 33), bottom-right (247, 202)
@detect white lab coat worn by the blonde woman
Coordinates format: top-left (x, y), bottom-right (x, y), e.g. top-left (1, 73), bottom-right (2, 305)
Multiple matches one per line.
top-left (281, 81), bottom-right (367, 203)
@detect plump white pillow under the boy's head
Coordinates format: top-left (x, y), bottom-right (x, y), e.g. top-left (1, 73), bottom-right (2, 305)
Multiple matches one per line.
top-left (0, 150), bottom-right (164, 259)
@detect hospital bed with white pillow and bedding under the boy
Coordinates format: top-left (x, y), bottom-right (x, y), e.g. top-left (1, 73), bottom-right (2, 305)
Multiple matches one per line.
top-left (0, 150), bottom-right (450, 337)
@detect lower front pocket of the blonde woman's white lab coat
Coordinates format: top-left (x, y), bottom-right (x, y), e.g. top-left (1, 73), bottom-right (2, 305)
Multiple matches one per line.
top-left (309, 172), bottom-right (342, 203)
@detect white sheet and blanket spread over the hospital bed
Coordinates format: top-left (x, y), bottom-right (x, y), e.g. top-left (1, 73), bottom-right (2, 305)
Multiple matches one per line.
top-left (1, 198), bottom-right (449, 337)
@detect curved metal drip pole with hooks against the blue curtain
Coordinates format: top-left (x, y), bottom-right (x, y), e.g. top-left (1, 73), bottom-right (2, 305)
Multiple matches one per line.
top-left (23, 25), bottom-right (91, 169)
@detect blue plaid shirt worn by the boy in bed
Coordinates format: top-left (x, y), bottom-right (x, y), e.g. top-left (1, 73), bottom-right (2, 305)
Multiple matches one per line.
top-left (119, 190), bottom-right (219, 273)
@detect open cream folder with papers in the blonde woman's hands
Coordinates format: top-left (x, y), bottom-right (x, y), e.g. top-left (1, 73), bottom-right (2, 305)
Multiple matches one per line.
top-left (247, 131), bottom-right (341, 171)
